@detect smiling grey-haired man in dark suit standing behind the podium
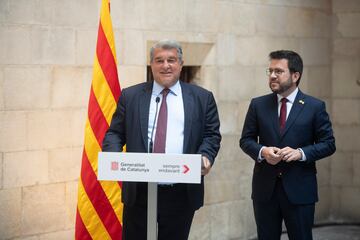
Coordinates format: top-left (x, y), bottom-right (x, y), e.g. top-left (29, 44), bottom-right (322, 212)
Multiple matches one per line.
top-left (103, 40), bottom-right (221, 240)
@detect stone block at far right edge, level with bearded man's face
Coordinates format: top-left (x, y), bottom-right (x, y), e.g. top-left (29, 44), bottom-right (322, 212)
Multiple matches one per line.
top-left (332, 59), bottom-right (360, 98)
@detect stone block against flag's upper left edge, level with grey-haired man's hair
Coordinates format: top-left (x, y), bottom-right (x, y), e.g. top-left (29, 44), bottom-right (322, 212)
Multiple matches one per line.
top-left (75, 28), bottom-right (97, 66)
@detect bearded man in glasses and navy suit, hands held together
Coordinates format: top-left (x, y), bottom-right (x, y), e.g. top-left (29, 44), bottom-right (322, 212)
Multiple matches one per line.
top-left (240, 50), bottom-right (335, 240)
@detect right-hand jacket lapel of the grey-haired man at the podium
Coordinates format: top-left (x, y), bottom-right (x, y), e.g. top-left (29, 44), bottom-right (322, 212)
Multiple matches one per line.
top-left (180, 82), bottom-right (195, 153)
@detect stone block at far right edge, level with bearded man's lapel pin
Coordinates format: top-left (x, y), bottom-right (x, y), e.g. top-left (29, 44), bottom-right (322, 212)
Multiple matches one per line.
top-left (333, 98), bottom-right (360, 125)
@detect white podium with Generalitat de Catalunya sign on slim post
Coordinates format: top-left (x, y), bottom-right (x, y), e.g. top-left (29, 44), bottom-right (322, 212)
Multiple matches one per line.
top-left (98, 152), bottom-right (201, 240)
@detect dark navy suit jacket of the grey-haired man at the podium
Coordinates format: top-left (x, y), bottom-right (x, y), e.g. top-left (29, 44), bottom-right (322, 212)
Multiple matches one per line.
top-left (102, 82), bottom-right (221, 209)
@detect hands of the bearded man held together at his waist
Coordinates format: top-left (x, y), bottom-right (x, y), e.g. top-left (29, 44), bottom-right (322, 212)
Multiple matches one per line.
top-left (261, 147), bottom-right (302, 165)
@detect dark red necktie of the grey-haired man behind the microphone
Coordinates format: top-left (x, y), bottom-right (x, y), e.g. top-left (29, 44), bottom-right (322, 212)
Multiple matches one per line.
top-left (154, 88), bottom-right (170, 153)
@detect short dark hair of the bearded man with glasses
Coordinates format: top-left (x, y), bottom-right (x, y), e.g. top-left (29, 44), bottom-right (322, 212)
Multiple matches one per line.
top-left (269, 50), bottom-right (303, 86)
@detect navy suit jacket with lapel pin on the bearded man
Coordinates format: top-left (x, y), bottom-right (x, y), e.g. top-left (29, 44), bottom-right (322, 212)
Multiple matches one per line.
top-left (240, 90), bottom-right (335, 204)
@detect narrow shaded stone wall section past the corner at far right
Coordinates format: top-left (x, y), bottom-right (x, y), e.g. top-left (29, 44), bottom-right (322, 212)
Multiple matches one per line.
top-left (330, 0), bottom-right (360, 222)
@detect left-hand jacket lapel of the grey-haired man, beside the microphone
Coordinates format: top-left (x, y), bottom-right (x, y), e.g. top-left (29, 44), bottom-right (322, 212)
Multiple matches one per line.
top-left (139, 83), bottom-right (152, 150)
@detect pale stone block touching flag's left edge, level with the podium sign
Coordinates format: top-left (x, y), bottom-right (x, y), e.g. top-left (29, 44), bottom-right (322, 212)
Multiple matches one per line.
top-left (49, 147), bottom-right (82, 183)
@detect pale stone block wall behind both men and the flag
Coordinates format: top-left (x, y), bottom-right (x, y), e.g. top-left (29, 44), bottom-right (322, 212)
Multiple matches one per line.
top-left (0, 0), bottom-right (360, 240)
